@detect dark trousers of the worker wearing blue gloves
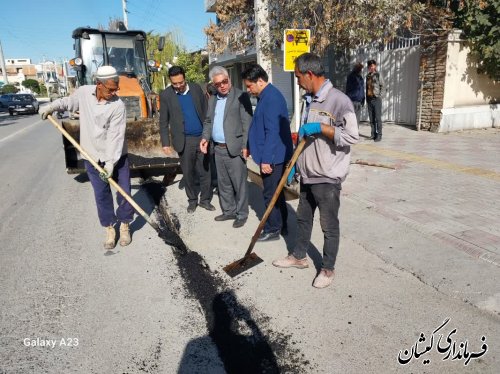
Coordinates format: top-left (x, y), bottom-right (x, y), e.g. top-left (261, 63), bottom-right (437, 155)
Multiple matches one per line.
top-left (292, 183), bottom-right (341, 270)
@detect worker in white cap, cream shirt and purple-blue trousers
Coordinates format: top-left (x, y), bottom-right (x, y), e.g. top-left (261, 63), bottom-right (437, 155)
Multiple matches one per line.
top-left (41, 66), bottom-right (134, 249)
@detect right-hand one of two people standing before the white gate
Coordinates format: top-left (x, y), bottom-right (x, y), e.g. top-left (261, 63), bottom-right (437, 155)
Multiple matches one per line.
top-left (366, 60), bottom-right (385, 142)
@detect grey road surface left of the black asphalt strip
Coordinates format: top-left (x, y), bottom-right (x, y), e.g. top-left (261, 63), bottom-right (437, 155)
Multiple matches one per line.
top-left (0, 114), bottom-right (221, 374)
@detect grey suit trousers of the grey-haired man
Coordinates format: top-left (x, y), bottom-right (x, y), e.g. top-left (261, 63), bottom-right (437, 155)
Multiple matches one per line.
top-left (214, 145), bottom-right (248, 219)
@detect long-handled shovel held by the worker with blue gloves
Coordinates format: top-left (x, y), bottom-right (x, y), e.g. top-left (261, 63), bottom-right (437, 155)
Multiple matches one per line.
top-left (223, 138), bottom-right (306, 278)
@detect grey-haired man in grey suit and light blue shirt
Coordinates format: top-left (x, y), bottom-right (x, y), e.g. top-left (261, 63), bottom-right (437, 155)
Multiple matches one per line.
top-left (200, 66), bottom-right (252, 228)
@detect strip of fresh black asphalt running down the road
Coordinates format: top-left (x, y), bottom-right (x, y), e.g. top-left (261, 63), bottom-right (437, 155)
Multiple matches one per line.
top-left (143, 182), bottom-right (312, 373)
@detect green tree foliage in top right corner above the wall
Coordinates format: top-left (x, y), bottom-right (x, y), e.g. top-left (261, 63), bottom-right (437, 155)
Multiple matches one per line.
top-left (455, 0), bottom-right (500, 81)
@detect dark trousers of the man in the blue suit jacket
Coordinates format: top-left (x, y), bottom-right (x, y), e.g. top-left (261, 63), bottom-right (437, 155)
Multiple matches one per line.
top-left (261, 164), bottom-right (288, 232)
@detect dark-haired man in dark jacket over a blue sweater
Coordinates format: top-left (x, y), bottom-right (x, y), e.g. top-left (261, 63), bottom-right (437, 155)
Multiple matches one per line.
top-left (160, 66), bottom-right (215, 213)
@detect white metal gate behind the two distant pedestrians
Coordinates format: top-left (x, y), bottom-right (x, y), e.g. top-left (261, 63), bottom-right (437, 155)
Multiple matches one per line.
top-left (328, 37), bottom-right (420, 126)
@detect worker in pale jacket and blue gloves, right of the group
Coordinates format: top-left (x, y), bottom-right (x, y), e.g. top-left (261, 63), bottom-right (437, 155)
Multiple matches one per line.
top-left (273, 53), bottom-right (359, 288)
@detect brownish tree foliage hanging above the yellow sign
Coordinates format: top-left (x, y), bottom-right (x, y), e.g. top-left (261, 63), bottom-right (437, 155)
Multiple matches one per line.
top-left (205, 0), bottom-right (451, 55)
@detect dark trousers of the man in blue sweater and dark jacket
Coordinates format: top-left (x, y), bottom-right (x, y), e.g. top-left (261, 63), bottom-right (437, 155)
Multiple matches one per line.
top-left (179, 136), bottom-right (213, 204)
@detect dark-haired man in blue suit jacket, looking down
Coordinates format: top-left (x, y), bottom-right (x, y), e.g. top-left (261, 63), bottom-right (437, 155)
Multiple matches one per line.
top-left (241, 64), bottom-right (293, 241)
